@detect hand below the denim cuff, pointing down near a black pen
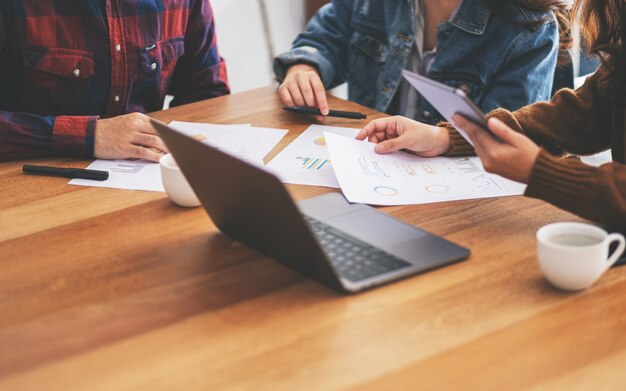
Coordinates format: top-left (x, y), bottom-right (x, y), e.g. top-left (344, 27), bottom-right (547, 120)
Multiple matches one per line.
top-left (278, 64), bottom-right (330, 121)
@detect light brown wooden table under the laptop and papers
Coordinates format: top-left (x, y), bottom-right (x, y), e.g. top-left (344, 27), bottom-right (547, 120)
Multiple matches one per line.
top-left (0, 88), bottom-right (626, 391)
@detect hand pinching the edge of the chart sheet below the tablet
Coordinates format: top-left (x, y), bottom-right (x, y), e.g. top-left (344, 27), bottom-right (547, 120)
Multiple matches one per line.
top-left (356, 115), bottom-right (450, 157)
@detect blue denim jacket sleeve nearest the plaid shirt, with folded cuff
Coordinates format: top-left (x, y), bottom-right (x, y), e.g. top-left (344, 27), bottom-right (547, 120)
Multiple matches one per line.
top-left (274, 0), bottom-right (353, 88)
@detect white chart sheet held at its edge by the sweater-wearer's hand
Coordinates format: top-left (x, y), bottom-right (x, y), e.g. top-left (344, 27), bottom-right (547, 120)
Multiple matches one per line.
top-left (325, 133), bottom-right (526, 205)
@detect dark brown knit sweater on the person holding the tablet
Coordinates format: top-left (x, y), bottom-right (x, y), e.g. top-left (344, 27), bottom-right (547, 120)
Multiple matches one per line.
top-left (446, 69), bottom-right (626, 231)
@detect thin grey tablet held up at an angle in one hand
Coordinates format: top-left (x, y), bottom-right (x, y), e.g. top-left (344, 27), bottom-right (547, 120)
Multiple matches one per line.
top-left (402, 70), bottom-right (498, 146)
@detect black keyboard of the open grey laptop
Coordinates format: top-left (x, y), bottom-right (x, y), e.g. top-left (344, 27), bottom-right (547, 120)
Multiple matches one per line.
top-left (304, 215), bottom-right (411, 282)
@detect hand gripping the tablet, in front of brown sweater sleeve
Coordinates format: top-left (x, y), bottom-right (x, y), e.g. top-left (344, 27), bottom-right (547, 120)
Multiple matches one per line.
top-left (452, 114), bottom-right (539, 183)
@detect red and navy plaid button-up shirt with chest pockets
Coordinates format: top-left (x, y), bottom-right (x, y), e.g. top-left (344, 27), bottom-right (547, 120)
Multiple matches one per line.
top-left (0, 0), bottom-right (229, 161)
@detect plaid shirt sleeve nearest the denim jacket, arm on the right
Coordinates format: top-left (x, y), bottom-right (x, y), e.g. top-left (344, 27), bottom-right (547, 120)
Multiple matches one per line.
top-left (168, 0), bottom-right (230, 107)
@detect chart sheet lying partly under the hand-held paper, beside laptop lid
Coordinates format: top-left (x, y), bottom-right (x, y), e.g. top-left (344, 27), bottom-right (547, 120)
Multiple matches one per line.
top-left (266, 125), bottom-right (360, 188)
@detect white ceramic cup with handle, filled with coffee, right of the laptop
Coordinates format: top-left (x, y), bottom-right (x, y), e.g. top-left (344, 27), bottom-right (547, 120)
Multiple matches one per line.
top-left (537, 223), bottom-right (626, 291)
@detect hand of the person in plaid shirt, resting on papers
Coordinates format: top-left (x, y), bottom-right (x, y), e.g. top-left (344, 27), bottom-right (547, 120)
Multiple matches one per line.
top-left (93, 113), bottom-right (169, 162)
